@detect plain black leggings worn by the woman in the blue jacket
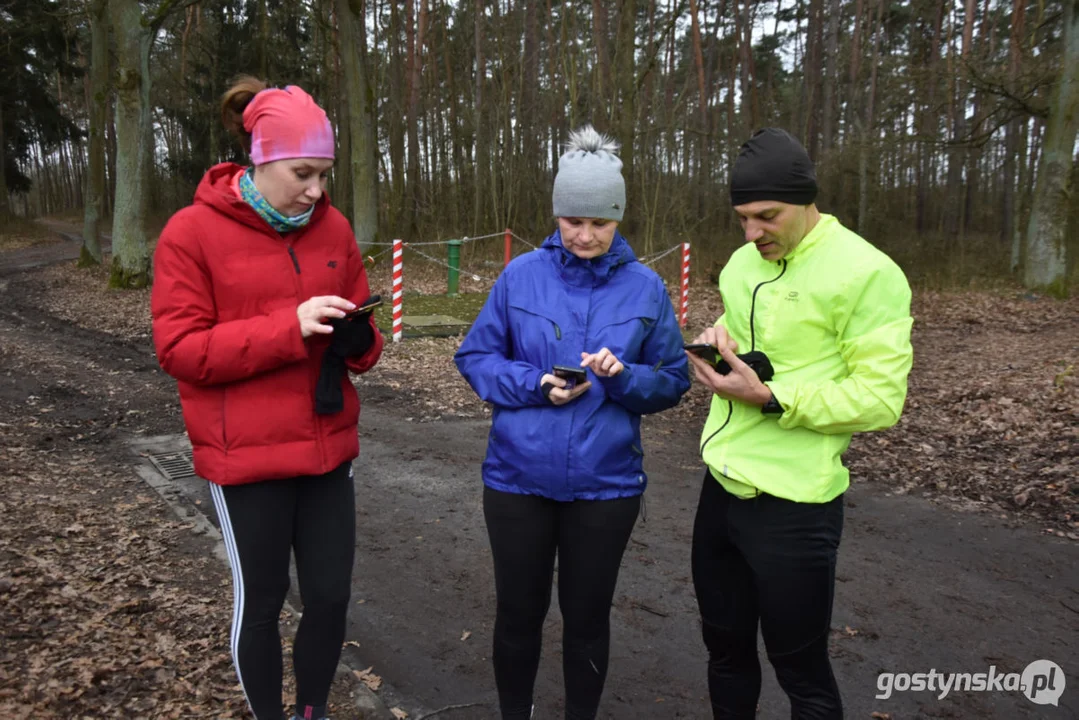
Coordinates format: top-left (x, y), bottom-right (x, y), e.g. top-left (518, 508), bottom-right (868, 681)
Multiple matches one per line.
top-left (483, 487), bottom-right (641, 720)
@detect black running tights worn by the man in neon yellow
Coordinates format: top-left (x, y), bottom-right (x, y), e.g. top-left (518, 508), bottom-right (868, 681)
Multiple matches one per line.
top-left (693, 473), bottom-right (843, 720)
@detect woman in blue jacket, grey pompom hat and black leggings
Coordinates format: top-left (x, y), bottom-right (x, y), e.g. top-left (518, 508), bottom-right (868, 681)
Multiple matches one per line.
top-left (454, 126), bottom-right (689, 720)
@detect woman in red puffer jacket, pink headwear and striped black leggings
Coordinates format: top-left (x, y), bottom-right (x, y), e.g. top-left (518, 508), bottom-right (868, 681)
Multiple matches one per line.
top-left (151, 78), bottom-right (382, 720)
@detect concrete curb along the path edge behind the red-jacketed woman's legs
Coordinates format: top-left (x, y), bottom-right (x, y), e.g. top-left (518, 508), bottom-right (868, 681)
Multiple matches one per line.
top-left (128, 435), bottom-right (395, 720)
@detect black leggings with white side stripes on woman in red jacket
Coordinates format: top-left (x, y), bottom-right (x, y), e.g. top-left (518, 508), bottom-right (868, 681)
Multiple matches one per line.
top-left (203, 462), bottom-right (356, 720)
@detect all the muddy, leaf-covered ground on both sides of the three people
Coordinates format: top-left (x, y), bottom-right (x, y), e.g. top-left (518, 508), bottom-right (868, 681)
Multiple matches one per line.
top-left (0, 232), bottom-right (1079, 720)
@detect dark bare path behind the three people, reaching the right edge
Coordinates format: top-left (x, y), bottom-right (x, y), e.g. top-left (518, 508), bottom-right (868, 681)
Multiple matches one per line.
top-left (156, 403), bottom-right (1079, 719)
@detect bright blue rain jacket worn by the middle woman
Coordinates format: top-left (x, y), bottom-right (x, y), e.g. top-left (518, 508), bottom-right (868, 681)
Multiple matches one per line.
top-left (454, 232), bottom-right (689, 501)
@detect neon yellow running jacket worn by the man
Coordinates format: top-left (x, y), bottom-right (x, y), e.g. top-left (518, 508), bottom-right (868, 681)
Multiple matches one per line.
top-left (701, 214), bottom-right (913, 503)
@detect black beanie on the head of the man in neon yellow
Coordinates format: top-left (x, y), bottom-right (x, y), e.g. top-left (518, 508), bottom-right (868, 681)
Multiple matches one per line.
top-left (730, 127), bottom-right (817, 206)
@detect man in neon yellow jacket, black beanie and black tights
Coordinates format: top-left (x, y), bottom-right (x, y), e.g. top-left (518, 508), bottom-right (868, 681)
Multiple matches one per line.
top-left (689, 128), bottom-right (913, 720)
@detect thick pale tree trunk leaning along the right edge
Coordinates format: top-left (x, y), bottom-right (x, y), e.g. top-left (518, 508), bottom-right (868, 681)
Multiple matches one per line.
top-left (1023, 0), bottom-right (1079, 297)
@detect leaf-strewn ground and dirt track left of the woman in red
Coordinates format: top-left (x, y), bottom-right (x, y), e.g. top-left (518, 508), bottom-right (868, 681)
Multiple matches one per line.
top-left (0, 263), bottom-right (371, 720)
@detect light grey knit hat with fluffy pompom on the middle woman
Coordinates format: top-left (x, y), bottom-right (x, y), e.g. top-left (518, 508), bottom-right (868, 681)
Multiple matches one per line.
top-left (551, 125), bottom-right (626, 222)
